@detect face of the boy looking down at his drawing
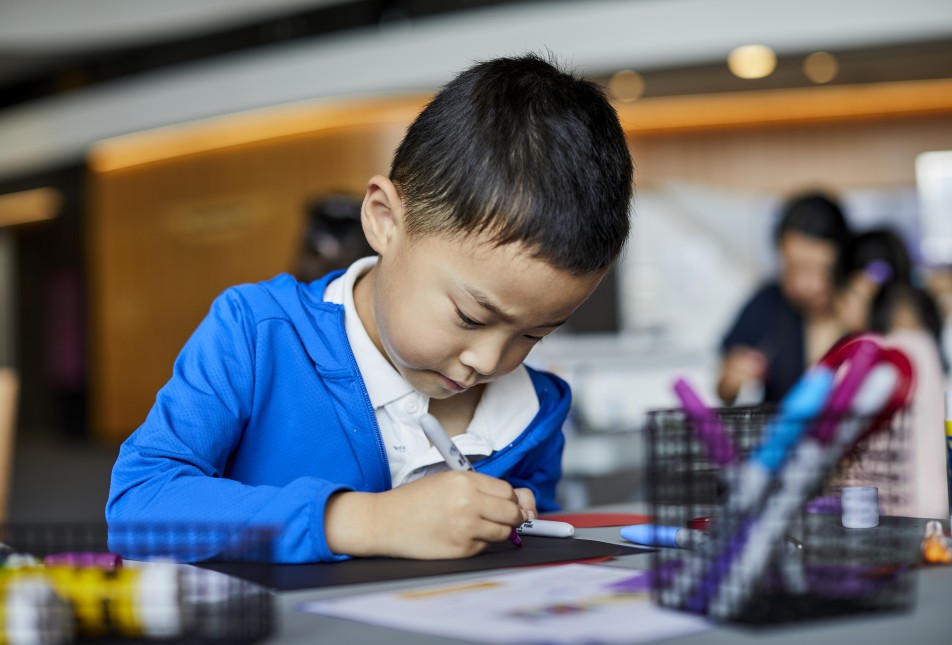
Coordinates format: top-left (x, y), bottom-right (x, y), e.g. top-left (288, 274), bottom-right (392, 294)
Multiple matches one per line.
top-left (354, 178), bottom-right (603, 399)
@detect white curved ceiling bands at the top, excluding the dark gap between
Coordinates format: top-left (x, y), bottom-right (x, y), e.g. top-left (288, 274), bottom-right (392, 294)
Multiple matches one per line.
top-left (0, 0), bottom-right (952, 179)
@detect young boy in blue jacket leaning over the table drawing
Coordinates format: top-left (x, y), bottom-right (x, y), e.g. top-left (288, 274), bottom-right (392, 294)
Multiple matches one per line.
top-left (106, 55), bottom-right (632, 562)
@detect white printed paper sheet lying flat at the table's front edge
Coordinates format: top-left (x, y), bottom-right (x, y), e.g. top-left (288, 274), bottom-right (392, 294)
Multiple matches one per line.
top-left (299, 564), bottom-right (710, 645)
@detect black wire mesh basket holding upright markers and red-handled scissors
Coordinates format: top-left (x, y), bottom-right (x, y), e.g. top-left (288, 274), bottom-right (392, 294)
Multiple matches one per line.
top-left (645, 407), bottom-right (921, 624)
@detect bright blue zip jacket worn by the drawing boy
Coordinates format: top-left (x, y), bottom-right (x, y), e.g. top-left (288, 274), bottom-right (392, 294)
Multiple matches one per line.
top-left (106, 272), bottom-right (571, 562)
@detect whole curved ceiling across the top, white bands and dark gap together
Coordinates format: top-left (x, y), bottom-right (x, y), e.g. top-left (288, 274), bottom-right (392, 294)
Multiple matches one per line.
top-left (0, 0), bottom-right (952, 180)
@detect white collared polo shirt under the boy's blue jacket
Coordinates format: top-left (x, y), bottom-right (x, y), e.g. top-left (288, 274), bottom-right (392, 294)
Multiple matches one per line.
top-left (324, 256), bottom-right (539, 488)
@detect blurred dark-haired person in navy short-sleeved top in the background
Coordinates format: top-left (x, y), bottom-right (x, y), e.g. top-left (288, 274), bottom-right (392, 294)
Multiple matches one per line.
top-left (717, 192), bottom-right (851, 404)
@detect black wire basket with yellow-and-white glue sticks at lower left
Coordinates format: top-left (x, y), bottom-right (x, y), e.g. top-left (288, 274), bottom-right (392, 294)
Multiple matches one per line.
top-left (0, 524), bottom-right (274, 643)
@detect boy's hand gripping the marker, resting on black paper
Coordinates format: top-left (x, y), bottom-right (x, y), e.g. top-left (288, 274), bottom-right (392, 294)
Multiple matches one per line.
top-left (324, 471), bottom-right (520, 560)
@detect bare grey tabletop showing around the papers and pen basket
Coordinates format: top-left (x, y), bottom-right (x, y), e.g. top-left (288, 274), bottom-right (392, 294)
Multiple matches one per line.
top-left (265, 505), bottom-right (952, 645)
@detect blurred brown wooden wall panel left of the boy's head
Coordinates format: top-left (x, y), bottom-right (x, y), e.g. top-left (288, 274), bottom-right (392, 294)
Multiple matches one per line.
top-left (89, 112), bottom-right (409, 443)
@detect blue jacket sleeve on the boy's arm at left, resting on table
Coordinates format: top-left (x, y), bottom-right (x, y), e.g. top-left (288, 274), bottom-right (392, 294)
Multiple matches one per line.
top-left (106, 289), bottom-right (354, 562)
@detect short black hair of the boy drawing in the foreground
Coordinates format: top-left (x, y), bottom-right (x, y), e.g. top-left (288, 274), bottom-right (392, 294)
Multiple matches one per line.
top-left (390, 54), bottom-right (633, 274)
